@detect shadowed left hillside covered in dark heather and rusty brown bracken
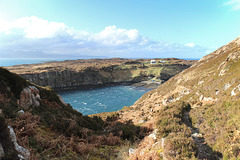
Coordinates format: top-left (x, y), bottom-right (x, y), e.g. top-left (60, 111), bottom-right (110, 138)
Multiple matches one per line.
top-left (0, 68), bottom-right (149, 160)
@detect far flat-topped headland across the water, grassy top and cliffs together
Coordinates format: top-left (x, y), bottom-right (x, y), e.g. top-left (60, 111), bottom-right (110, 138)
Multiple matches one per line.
top-left (8, 59), bottom-right (194, 89)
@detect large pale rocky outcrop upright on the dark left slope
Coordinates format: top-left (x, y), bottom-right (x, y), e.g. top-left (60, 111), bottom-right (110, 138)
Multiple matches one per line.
top-left (19, 86), bottom-right (41, 109)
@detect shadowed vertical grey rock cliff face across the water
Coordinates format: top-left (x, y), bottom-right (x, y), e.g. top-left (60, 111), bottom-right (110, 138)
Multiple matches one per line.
top-left (20, 67), bottom-right (135, 89)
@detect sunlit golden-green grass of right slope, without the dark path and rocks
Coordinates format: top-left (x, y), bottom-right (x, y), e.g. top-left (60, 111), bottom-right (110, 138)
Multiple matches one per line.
top-left (125, 39), bottom-right (240, 159)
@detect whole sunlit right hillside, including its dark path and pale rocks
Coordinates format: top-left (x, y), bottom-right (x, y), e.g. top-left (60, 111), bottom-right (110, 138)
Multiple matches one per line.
top-left (110, 38), bottom-right (240, 160)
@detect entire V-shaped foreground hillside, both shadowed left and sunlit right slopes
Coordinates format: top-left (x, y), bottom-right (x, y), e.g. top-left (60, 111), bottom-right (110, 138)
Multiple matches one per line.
top-left (0, 38), bottom-right (240, 160)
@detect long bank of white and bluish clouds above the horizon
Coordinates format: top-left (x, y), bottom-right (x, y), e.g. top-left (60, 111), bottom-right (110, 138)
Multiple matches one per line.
top-left (0, 17), bottom-right (208, 59)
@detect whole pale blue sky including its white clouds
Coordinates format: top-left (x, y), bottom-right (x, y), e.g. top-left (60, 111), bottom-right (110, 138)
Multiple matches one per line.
top-left (0, 0), bottom-right (240, 59)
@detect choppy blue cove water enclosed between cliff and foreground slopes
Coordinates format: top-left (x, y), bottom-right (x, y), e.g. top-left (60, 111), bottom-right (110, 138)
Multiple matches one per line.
top-left (57, 85), bottom-right (150, 115)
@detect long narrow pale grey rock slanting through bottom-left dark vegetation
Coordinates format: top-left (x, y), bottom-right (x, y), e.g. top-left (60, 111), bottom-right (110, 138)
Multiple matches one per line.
top-left (8, 126), bottom-right (30, 159)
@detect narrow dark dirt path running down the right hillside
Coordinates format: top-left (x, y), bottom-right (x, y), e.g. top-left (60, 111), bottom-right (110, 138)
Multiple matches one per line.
top-left (183, 111), bottom-right (222, 160)
